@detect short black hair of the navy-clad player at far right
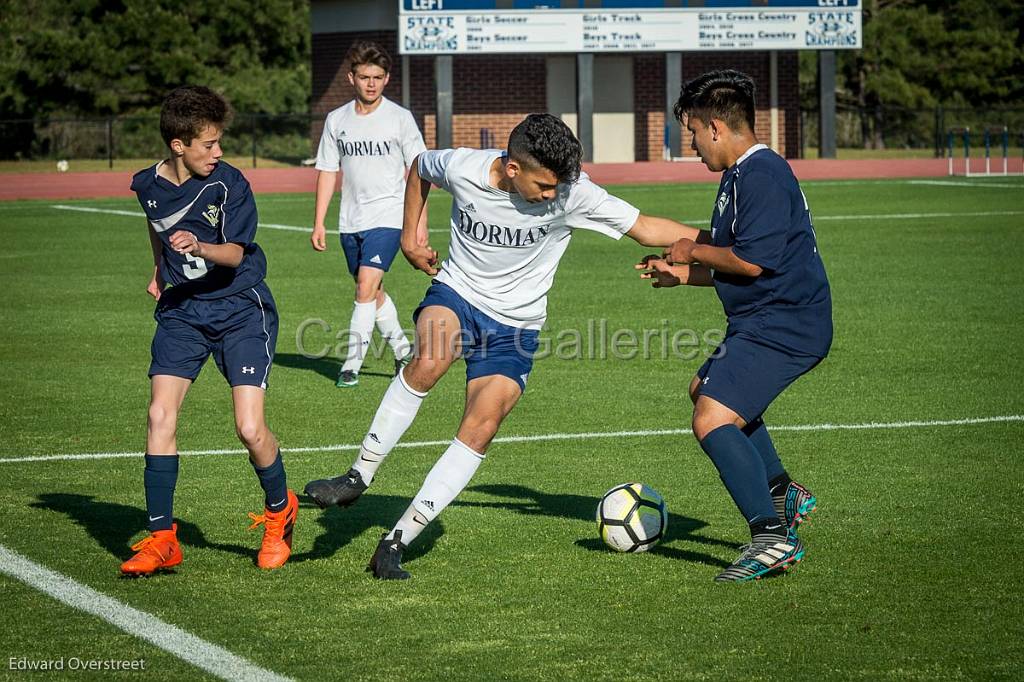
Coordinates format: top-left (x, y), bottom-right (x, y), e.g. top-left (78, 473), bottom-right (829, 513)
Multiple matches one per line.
top-left (672, 69), bottom-right (755, 131)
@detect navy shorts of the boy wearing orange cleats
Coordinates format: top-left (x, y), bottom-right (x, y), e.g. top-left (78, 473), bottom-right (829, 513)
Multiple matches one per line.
top-left (150, 282), bottom-right (278, 389)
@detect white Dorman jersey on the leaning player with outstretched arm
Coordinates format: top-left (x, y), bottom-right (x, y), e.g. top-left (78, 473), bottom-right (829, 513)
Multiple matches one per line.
top-left (417, 148), bottom-right (640, 329)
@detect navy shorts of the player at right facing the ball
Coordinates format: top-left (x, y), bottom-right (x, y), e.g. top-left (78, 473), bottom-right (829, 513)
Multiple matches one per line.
top-left (697, 335), bottom-right (821, 424)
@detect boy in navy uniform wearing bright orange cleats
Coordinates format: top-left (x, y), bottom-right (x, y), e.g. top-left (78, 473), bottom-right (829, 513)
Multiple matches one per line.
top-left (121, 87), bottom-right (298, 576)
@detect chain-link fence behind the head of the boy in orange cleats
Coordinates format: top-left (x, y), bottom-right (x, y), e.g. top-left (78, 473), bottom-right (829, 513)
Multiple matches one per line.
top-left (0, 114), bottom-right (324, 167)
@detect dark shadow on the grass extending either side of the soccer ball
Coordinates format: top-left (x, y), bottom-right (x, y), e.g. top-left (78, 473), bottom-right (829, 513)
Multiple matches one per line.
top-left (455, 485), bottom-right (739, 567)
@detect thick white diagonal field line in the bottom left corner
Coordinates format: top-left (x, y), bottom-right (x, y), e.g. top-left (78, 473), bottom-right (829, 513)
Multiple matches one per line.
top-left (0, 545), bottom-right (289, 682)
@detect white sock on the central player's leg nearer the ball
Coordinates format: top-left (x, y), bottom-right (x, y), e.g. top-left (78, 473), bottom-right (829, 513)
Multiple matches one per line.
top-left (388, 438), bottom-right (483, 547)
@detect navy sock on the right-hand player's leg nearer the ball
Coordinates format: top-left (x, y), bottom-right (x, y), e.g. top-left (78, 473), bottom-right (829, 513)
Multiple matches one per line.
top-left (700, 424), bottom-right (776, 523)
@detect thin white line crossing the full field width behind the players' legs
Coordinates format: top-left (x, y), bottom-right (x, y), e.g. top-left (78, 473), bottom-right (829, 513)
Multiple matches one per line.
top-left (0, 415), bottom-right (1024, 464)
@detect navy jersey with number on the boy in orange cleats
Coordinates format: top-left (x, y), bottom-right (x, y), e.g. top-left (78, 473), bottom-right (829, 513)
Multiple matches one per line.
top-left (131, 162), bottom-right (266, 299)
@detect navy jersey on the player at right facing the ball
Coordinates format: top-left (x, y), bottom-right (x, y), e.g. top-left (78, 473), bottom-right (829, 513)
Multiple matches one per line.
top-left (711, 144), bottom-right (833, 357)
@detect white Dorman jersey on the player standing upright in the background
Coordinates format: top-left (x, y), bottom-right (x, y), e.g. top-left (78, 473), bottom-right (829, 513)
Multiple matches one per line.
top-left (316, 97), bottom-right (427, 232)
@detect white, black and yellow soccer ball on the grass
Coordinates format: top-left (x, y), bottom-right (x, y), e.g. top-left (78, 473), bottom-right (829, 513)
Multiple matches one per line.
top-left (597, 483), bottom-right (669, 552)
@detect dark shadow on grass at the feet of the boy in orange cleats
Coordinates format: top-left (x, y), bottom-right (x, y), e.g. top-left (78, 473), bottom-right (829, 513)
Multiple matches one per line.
top-left (29, 493), bottom-right (257, 563)
